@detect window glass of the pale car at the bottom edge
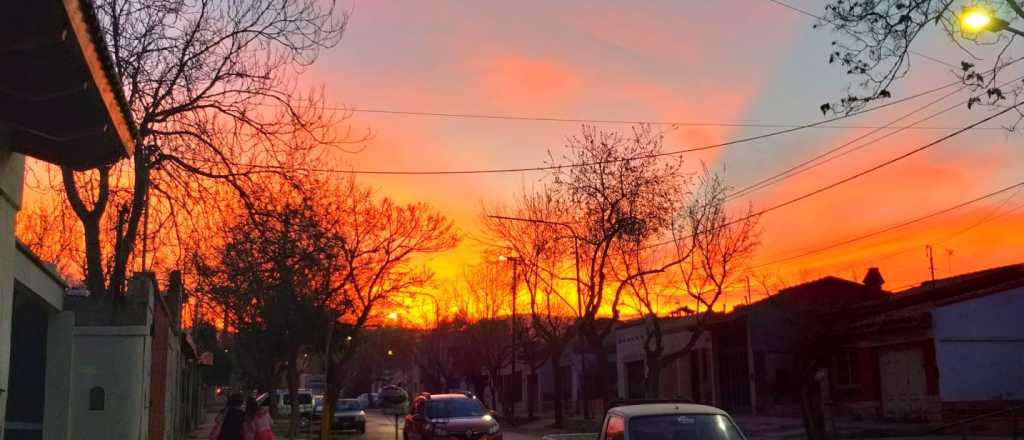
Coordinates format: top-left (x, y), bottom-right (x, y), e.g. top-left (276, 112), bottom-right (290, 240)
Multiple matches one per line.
top-left (628, 414), bottom-right (742, 440)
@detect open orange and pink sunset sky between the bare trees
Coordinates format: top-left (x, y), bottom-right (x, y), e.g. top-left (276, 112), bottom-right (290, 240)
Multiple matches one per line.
top-left (290, 0), bottom-right (1024, 309)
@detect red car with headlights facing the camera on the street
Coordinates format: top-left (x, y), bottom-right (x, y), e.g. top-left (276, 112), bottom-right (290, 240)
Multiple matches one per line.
top-left (402, 393), bottom-right (502, 440)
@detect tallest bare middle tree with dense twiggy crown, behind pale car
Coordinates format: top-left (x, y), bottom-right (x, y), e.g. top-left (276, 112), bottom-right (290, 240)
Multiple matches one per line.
top-left (552, 126), bottom-right (685, 409)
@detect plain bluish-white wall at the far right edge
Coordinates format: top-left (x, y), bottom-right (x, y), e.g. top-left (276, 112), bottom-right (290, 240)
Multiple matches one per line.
top-left (932, 288), bottom-right (1024, 401)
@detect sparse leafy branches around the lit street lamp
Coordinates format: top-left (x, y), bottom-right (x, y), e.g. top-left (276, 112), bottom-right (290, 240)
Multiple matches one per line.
top-left (815, 0), bottom-right (1024, 121)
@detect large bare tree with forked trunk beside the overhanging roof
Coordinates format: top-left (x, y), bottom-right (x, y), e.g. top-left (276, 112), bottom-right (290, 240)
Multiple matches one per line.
top-left (51, 0), bottom-right (356, 295)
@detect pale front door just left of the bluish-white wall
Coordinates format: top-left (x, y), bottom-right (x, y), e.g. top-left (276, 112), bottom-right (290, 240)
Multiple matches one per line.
top-left (879, 347), bottom-right (927, 421)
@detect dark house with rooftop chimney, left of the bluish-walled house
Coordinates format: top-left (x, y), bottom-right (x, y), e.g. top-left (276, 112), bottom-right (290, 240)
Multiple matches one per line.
top-left (711, 269), bottom-right (889, 415)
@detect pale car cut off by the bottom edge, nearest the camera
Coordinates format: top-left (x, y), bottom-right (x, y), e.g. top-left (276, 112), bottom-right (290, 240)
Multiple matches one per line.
top-left (599, 401), bottom-right (745, 440)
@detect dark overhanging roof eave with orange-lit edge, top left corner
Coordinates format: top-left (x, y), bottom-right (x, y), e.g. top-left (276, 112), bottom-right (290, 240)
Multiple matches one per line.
top-left (0, 0), bottom-right (136, 170)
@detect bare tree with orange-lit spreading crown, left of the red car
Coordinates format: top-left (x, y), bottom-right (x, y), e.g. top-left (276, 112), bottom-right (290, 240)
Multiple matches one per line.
top-left (321, 178), bottom-right (459, 433)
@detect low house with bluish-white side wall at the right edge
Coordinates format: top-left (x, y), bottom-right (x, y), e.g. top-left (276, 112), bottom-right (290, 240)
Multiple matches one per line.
top-left (829, 265), bottom-right (1024, 423)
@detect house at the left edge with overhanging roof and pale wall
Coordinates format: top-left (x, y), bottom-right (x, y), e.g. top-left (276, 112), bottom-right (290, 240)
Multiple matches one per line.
top-left (0, 0), bottom-right (135, 439)
